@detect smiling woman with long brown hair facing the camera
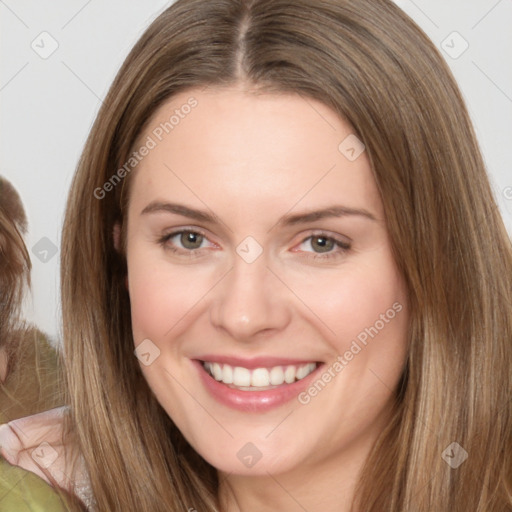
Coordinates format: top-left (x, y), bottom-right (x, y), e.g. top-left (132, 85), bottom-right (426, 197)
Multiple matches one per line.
top-left (2, 0), bottom-right (512, 512)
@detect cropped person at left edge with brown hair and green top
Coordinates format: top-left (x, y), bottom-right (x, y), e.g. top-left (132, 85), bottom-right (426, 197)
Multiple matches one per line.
top-left (0, 176), bottom-right (68, 512)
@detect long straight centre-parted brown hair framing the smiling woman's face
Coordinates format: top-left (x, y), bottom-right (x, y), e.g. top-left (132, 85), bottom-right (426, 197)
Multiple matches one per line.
top-left (61, 0), bottom-right (512, 512)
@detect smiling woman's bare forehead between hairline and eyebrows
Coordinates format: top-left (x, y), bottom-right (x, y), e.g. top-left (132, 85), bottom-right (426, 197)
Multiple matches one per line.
top-left (130, 87), bottom-right (381, 224)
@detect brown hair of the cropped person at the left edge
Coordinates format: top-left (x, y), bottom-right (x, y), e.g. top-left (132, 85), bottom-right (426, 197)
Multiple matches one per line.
top-left (0, 176), bottom-right (62, 423)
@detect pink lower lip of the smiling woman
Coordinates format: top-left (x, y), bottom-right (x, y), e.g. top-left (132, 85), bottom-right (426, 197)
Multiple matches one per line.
top-left (192, 360), bottom-right (324, 412)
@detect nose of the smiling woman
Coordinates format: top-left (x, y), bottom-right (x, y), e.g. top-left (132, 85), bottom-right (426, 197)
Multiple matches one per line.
top-left (210, 255), bottom-right (292, 341)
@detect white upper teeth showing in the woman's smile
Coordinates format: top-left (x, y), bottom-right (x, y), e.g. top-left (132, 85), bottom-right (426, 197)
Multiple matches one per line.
top-left (201, 361), bottom-right (319, 391)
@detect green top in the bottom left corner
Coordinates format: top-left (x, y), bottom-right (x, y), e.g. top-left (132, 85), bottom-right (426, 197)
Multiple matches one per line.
top-left (0, 457), bottom-right (67, 512)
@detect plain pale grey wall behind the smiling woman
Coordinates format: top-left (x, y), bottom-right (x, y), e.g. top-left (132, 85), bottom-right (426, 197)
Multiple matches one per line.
top-left (0, 0), bottom-right (512, 341)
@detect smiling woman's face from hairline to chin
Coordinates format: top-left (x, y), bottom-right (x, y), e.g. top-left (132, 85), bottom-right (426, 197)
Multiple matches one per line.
top-left (127, 87), bottom-right (408, 475)
